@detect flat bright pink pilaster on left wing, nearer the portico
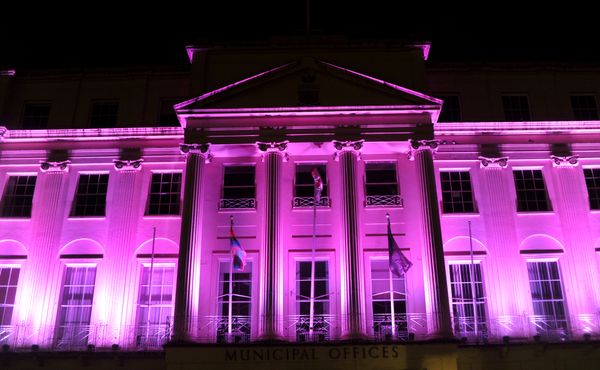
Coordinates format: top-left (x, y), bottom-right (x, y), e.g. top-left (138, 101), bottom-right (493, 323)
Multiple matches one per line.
top-left (103, 159), bottom-right (142, 345)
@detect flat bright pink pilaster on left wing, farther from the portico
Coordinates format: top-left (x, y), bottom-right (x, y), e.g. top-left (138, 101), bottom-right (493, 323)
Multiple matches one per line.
top-left (28, 161), bottom-right (69, 346)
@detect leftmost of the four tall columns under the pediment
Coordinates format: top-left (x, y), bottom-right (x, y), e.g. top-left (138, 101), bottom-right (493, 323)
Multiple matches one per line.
top-left (173, 144), bottom-right (210, 342)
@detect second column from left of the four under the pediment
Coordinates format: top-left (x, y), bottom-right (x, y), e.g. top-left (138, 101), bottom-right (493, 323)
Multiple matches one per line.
top-left (257, 141), bottom-right (287, 341)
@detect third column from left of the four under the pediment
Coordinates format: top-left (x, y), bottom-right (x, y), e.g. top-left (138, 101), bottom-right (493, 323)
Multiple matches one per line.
top-left (333, 140), bottom-right (365, 339)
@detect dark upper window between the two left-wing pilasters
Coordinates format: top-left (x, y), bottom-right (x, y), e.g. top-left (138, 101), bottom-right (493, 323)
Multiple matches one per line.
top-left (71, 174), bottom-right (108, 217)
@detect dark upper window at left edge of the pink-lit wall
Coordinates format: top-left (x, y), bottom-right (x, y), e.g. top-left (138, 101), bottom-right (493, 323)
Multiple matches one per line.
top-left (2, 176), bottom-right (37, 218)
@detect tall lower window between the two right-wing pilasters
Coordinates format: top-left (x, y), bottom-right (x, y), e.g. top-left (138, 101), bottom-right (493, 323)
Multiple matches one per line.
top-left (527, 261), bottom-right (567, 339)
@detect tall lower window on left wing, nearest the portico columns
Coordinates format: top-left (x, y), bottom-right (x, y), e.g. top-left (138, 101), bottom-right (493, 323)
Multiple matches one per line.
top-left (136, 266), bottom-right (175, 348)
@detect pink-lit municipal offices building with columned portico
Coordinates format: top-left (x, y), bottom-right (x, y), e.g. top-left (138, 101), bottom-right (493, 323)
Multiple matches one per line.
top-left (0, 41), bottom-right (600, 368)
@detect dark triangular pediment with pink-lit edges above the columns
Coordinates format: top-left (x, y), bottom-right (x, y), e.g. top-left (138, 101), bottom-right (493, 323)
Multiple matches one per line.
top-left (176, 58), bottom-right (441, 113)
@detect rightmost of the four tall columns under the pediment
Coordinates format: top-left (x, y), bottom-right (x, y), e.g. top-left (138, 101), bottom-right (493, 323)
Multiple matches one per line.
top-left (410, 140), bottom-right (452, 338)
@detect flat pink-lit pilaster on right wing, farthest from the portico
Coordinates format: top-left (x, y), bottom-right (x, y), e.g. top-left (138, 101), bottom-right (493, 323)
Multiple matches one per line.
top-left (551, 156), bottom-right (600, 336)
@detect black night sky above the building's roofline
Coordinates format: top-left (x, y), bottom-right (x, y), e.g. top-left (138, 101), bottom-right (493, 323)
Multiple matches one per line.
top-left (0, 0), bottom-right (600, 68)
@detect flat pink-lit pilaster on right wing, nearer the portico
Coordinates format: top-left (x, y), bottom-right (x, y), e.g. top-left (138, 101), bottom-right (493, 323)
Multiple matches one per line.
top-left (479, 157), bottom-right (531, 337)
